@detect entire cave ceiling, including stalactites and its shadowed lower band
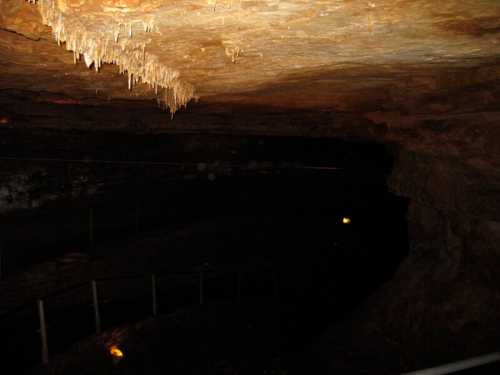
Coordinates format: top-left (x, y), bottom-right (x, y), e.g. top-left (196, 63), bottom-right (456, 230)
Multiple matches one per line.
top-left (0, 0), bottom-right (500, 153)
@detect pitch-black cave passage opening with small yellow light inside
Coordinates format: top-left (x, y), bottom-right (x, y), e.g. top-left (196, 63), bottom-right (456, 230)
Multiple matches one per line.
top-left (1, 136), bottom-right (408, 373)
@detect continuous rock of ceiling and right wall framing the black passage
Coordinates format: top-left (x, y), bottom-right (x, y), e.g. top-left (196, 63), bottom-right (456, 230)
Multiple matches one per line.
top-left (0, 0), bottom-right (500, 372)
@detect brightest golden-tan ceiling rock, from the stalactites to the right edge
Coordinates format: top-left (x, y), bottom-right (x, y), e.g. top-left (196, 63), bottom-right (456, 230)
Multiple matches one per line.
top-left (31, 0), bottom-right (500, 111)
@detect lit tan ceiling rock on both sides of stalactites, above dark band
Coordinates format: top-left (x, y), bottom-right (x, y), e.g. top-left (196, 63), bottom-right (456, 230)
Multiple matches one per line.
top-left (0, 0), bottom-right (500, 111)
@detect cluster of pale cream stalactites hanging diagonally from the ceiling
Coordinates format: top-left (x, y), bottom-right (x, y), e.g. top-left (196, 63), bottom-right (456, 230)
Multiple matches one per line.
top-left (27, 0), bottom-right (195, 116)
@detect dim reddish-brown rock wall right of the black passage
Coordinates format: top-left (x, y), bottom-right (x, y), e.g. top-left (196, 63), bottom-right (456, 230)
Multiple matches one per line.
top-left (306, 61), bottom-right (500, 373)
